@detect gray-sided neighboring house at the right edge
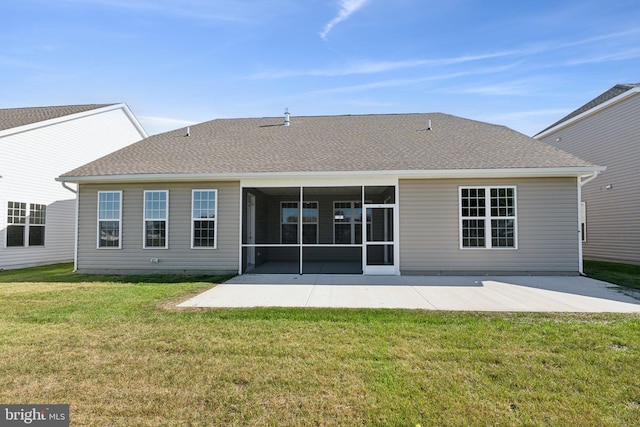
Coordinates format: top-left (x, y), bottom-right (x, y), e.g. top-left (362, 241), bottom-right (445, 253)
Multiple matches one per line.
top-left (534, 83), bottom-right (640, 264)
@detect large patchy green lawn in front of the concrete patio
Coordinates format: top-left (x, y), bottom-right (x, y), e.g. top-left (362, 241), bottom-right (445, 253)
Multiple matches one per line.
top-left (0, 265), bottom-right (640, 427)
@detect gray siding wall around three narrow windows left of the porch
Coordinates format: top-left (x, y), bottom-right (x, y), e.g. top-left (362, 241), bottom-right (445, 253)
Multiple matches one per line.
top-left (78, 182), bottom-right (240, 273)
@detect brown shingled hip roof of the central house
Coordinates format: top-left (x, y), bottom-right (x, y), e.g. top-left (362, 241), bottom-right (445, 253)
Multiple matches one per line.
top-left (60, 113), bottom-right (593, 181)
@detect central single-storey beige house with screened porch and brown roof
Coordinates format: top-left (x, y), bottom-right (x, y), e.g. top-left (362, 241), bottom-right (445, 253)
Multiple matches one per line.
top-left (58, 113), bottom-right (602, 274)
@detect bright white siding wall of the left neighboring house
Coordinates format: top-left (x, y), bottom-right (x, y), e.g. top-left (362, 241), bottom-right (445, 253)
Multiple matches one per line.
top-left (0, 109), bottom-right (143, 269)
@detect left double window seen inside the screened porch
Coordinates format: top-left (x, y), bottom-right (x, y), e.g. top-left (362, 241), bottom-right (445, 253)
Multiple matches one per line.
top-left (280, 202), bottom-right (318, 244)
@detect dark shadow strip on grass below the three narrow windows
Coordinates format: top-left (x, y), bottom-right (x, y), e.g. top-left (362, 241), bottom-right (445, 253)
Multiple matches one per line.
top-left (0, 263), bottom-right (233, 283)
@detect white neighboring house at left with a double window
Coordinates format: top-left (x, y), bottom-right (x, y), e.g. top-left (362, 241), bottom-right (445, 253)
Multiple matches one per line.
top-left (0, 104), bottom-right (148, 270)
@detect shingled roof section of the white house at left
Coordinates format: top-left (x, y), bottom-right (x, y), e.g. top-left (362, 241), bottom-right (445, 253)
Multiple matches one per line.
top-left (0, 104), bottom-right (114, 131)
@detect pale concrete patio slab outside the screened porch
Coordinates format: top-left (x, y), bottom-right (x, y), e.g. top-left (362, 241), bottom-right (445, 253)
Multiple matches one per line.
top-left (178, 274), bottom-right (640, 313)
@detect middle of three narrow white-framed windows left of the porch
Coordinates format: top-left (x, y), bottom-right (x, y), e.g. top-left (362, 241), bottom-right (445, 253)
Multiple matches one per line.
top-left (144, 190), bottom-right (169, 249)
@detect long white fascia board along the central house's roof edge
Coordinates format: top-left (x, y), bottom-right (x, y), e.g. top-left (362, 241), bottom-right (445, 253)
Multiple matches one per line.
top-left (56, 166), bottom-right (606, 184)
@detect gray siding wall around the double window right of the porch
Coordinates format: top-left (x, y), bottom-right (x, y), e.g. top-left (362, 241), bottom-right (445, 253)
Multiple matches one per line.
top-left (399, 178), bottom-right (579, 274)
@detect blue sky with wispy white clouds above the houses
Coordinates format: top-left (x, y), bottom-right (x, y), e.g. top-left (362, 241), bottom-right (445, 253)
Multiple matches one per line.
top-left (0, 0), bottom-right (640, 135)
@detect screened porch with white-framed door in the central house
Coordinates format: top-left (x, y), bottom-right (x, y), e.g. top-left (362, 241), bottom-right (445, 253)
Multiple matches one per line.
top-left (241, 184), bottom-right (399, 274)
